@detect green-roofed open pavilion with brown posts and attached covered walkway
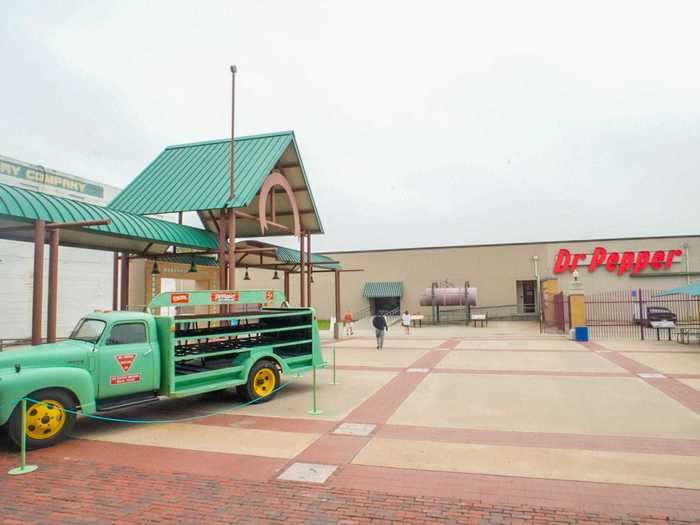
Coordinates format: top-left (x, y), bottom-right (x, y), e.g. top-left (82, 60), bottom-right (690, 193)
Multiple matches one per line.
top-left (0, 131), bottom-right (350, 344)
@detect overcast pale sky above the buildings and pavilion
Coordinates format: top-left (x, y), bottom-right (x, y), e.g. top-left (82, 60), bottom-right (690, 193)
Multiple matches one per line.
top-left (0, 0), bottom-right (700, 250)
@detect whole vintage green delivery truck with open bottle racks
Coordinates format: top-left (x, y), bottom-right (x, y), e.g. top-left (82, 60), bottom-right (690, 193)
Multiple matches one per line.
top-left (0, 290), bottom-right (325, 448)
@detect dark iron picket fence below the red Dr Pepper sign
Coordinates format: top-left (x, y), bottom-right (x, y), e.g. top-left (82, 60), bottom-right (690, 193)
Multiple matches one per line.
top-left (585, 288), bottom-right (700, 339)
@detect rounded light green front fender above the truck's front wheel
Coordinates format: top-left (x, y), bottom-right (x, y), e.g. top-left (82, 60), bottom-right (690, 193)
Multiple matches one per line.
top-left (0, 367), bottom-right (95, 425)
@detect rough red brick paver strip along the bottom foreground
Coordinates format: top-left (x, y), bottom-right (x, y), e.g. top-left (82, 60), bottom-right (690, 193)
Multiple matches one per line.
top-left (0, 455), bottom-right (693, 525)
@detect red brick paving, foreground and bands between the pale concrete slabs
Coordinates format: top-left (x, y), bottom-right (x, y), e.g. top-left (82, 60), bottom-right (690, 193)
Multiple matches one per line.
top-left (0, 332), bottom-right (700, 524)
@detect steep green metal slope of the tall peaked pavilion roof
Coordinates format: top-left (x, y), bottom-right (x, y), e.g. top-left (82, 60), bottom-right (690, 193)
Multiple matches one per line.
top-left (109, 131), bottom-right (304, 214)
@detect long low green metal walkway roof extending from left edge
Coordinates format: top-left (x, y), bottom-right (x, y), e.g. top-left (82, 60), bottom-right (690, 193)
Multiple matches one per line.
top-left (0, 184), bottom-right (218, 251)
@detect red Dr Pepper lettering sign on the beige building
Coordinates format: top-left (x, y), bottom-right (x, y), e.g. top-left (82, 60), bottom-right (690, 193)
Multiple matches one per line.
top-left (554, 246), bottom-right (683, 275)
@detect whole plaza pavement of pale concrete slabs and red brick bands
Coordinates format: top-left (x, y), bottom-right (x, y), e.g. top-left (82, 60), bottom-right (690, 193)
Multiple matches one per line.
top-left (0, 323), bottom-right (700, 523)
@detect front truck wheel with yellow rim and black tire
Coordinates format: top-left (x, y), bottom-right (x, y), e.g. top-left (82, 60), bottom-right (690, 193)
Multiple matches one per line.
top-left (7, 388), bottom-right (75, 450)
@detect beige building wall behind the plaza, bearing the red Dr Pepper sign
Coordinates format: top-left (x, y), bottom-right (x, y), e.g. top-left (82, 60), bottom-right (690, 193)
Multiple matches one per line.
top-left (132, 236), bottom-right (700, 319)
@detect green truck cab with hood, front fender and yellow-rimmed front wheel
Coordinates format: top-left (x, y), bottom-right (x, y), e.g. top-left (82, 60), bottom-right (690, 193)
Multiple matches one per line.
top-left (0, 312), bottom-right (160, 448)
